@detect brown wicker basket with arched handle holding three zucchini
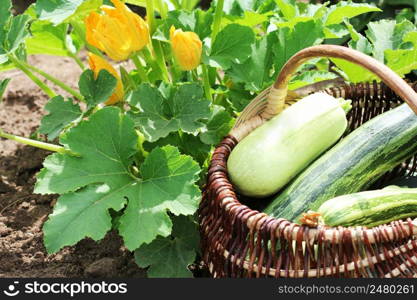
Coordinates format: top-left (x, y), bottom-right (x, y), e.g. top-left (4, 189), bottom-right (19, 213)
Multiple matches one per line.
top-left (199, 45), bottom-right (417, 277)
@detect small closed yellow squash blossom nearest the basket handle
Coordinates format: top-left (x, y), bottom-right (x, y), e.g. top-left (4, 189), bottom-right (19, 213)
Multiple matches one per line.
top-left (169, 26), bottom-right (202, 71)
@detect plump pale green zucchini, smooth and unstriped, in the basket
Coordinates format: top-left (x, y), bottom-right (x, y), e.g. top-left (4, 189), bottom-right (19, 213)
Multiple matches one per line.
top-left (227, 93), bottom-right (350, 197)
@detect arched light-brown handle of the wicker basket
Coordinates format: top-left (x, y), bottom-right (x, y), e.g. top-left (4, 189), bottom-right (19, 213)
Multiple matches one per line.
top-left (261, 45), bottom-right (417, 120)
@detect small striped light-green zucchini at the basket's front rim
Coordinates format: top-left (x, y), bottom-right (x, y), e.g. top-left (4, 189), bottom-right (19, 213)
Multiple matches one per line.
top-left (317, 187), bottom-right (417, 227)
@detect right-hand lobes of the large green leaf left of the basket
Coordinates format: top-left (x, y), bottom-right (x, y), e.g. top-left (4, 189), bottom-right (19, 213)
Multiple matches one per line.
top-left (119, 146), bottom-right (201, 250)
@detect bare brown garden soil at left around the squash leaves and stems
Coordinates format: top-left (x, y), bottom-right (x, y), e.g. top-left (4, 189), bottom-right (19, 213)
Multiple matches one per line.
top-left (0, 56), bottom-right (145, 278)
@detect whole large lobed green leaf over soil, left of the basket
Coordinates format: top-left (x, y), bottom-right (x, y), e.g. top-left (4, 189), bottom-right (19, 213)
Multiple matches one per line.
top-left (35, 107), bottom-right (201, 253)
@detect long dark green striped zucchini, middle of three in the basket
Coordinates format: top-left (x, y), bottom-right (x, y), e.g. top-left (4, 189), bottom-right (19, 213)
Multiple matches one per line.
top-left (264, 104), bottom-right (417, 221)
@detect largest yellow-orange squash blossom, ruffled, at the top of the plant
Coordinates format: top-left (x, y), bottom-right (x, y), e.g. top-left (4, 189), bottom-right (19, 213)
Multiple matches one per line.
top-left (85, 0), bottom-right (149, 61)
